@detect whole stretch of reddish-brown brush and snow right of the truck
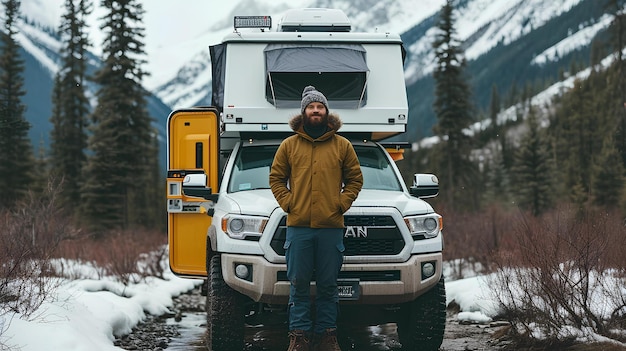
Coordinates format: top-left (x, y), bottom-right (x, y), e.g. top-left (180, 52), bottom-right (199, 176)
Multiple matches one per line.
top-left (442, 206), bottom-right (626, 350)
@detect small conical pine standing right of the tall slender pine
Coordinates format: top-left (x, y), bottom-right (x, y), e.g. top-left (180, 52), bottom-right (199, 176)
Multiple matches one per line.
top-left (513, 107), bottom-right (554, 216)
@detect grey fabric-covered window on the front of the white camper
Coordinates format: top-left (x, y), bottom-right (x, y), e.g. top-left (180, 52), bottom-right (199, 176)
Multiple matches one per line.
top-left (264, 44), bottom-right (368, 109)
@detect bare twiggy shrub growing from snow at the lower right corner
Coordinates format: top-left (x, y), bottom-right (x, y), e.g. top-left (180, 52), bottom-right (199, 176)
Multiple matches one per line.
top-left (494, 209), bottom-right (626, 340)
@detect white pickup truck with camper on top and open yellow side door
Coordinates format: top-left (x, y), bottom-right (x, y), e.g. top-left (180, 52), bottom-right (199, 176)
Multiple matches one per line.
top-left (167, 9), bottom-right (446, 351)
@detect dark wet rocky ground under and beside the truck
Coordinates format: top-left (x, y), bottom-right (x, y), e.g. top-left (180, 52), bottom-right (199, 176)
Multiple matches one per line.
top-left (115, 288), bottom-right (508, 351)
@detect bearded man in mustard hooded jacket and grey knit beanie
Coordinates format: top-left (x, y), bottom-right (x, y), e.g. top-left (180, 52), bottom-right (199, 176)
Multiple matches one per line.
top-left (269, 86), bottom-right (363, 351)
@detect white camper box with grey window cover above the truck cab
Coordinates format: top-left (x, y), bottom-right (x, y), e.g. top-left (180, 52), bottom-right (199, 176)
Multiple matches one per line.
top-left (210, 9), bottom-right (408, 148)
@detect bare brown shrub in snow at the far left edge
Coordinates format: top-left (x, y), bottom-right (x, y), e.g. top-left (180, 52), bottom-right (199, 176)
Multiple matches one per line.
top-left (0, 181), bottom-right (76, 319)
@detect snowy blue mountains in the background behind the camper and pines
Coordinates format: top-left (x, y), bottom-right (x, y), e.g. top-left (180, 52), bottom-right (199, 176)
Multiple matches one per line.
top-left (12, 0), bottom-right (611, 159)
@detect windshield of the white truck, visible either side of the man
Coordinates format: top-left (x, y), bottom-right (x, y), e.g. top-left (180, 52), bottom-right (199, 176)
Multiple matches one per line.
top-left (228, 145), bottom-right (402, 193)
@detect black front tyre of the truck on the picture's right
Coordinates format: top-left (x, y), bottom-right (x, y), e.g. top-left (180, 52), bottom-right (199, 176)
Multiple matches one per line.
top-left (397, 276), bottom-right (446, 351)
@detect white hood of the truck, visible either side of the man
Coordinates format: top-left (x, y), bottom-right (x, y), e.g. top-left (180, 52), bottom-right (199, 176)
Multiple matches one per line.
top-left (219, 189), bottom-right (434, 216)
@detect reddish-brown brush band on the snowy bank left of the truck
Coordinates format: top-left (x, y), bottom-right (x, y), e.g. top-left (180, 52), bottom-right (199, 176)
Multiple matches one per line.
top-left (0, 182), bottom-right (167, 324)
